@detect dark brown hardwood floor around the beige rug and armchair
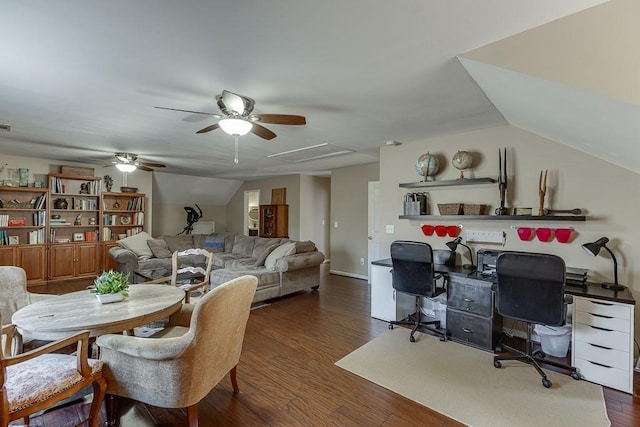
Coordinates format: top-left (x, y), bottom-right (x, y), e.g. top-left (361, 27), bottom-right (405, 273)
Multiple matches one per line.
top-left (18, 265), bottom-right (640, 427)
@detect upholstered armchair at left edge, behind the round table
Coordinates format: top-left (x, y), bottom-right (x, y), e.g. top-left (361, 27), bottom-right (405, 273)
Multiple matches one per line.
top-left (0, 266), bottom-right (57, 354)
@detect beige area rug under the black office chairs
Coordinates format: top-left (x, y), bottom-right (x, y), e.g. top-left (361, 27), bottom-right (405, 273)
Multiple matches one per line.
top-left (336, 328), bottom-right (611, 427)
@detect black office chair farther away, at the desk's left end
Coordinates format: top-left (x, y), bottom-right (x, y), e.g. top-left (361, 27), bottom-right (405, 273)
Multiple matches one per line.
top-left (389, 241), bottom-right (447, 342)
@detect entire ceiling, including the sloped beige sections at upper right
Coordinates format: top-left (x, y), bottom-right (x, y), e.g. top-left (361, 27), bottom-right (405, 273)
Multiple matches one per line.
top-left (0, 0), bottom-right (640, 179)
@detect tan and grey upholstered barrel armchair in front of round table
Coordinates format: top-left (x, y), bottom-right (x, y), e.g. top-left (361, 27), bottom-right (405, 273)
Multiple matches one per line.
top-left (97, 276), bottom-right (258, 426)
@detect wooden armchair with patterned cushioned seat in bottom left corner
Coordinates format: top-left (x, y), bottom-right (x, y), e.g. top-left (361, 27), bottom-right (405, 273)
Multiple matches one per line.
top-left (0, 319), bottom-right (107, 427)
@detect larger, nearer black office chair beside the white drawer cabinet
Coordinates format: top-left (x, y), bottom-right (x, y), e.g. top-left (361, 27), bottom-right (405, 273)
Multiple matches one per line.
top-left (493, 252), bottom-right (580, 388)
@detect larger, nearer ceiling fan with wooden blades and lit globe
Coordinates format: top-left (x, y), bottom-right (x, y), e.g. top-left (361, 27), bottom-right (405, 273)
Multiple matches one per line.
top-left (155, 90), bottom-right (307, 140)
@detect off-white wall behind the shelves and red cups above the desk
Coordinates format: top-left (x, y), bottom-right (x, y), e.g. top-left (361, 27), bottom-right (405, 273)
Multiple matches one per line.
top-left (380, 126), bottom-right (640, 336)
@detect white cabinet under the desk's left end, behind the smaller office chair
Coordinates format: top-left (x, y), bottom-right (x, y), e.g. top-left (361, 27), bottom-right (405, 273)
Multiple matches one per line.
top-left (371, 264), bottom-right (416, 322)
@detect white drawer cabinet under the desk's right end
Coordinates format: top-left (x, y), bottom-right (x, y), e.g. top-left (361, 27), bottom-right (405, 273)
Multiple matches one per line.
top-left (571, 296), bottom-right (634, 393)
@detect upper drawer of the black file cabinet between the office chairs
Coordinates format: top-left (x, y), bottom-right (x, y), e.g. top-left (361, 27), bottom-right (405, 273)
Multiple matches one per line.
top-left (447, 277), bottom-right (493, 317)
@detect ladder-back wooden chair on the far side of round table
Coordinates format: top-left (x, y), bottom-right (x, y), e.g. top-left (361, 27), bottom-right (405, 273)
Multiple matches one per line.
top-left (145, 248), bottom-right (213, 304)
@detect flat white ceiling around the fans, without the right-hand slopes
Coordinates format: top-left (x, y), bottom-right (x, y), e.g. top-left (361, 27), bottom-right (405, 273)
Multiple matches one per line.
top-left (0, 0), bottom-right (604, 179)
